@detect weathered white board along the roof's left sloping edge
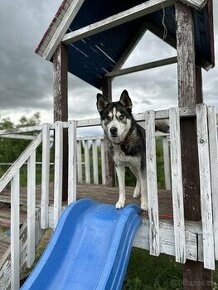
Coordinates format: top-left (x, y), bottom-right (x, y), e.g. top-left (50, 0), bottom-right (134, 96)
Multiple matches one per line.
top-left (39, 0), bottom-right (84, 60)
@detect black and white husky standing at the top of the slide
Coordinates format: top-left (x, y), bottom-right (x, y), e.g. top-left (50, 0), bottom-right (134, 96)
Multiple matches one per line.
top-left (97, 90), bottom-right (147, 210)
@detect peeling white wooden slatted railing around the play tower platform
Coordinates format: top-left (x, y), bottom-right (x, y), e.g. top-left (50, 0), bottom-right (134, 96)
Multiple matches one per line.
top-left (0, 105), bottom-right (218, 290)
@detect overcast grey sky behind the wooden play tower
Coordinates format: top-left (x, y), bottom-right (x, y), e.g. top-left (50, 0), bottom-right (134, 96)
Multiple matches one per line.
top-left (0, 0), bottom-right (218, 122)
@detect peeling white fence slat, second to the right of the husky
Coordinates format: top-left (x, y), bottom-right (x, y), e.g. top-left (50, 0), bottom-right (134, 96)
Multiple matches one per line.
top-left (169, 108), bottom-right (186, 263)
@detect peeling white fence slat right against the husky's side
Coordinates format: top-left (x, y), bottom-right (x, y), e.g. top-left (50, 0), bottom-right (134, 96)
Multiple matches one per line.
top-left (145, 111), bottom-right (160, 256)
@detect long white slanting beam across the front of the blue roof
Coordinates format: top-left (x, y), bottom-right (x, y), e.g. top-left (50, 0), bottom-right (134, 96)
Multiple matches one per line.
top-left (62, 0), bottom-right (175, 44)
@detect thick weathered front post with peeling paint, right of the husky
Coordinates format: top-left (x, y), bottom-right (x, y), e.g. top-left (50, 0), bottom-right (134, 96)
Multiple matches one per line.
top-left (175, 2), bottom-right (212, 290)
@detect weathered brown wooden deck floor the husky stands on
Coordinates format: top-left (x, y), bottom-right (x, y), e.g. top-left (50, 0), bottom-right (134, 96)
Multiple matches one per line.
top-left (0, 184), bottom-right (172, 260)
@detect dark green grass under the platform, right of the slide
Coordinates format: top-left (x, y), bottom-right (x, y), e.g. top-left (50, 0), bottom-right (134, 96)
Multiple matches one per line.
top-left (122, 248), bottom-right (182, 290)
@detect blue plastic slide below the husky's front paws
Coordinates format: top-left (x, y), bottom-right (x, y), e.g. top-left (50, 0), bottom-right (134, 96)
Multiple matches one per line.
top-left (21, 199), bottom-right (141, 290)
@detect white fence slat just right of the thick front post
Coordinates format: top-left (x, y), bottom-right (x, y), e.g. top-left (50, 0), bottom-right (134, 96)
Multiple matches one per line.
top-left (196, 104), bottom-right (215, 270)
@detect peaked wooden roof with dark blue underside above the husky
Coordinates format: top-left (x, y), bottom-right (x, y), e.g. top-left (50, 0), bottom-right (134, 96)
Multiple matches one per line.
top-left (36, 0), bottom-right (214, 88)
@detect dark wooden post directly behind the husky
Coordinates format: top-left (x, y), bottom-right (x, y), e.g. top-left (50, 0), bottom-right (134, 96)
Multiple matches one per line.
top-left (102, 77), bottom-right (115, 186)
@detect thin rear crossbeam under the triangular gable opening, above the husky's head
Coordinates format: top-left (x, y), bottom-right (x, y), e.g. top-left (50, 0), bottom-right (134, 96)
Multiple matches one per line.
top-left (106, 56), bottom-right (177, 77)
